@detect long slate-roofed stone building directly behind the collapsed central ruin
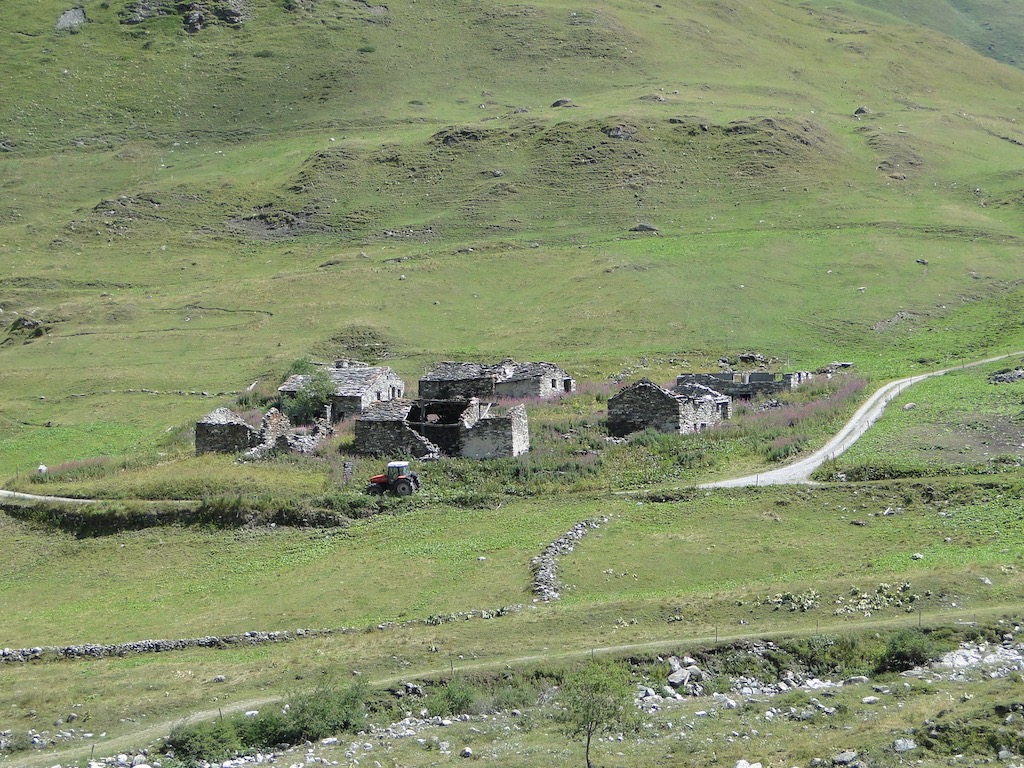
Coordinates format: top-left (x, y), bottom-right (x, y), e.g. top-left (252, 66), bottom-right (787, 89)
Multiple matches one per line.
top-left (420, 359), bottom-right (575, 400)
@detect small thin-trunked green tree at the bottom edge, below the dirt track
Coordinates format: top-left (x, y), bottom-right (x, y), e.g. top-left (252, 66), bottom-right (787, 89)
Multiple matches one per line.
top-left (559, 662), bottom-right (640, 768)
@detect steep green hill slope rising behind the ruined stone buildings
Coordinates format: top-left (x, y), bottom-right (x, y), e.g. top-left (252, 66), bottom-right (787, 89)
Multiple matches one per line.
top-left (0, 0), bottom-right (1024, 472)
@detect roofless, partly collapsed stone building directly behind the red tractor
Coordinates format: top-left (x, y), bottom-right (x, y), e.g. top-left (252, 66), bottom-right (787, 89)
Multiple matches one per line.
top-left (354, 397), bottom-right (529, 459)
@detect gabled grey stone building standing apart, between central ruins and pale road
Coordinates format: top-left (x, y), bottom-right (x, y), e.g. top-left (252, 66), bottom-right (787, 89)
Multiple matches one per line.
top-left (608, 379), bottom-right (732, 437)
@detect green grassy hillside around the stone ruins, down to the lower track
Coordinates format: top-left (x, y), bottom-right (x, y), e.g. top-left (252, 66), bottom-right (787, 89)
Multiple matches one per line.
top-left (6, 0), bottom-right (1024, 765)
